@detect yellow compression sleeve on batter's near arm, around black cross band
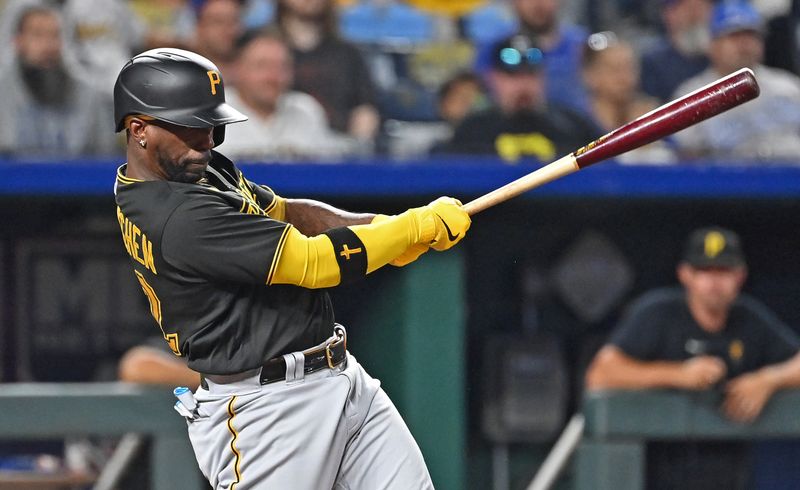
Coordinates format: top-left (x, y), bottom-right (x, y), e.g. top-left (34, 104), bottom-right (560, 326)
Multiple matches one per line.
top-left (269, 207), bottom-right (436, 289)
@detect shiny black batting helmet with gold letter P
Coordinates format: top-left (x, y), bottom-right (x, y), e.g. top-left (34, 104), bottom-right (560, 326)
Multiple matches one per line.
top-left (114, 48), bottom-right (247, 145)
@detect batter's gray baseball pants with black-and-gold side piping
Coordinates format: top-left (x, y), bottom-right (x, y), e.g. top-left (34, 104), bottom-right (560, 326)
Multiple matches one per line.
top-left (188, 354), bottom-right (433, 490)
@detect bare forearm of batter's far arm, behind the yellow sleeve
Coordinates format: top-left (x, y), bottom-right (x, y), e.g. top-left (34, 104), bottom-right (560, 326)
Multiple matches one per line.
top-left (285, 199), bottom-right (375, 236)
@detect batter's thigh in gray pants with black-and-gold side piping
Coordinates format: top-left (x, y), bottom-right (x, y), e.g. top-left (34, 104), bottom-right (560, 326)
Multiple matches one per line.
top-left (190, 376), bottom-right (350, 490)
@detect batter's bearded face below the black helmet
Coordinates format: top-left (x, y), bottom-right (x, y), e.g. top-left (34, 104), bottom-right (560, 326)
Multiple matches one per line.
top-left (147, 121), bottom-right (214, 182)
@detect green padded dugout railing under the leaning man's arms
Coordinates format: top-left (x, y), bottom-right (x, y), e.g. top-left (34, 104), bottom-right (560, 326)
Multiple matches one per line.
top-left (575, 390), bottom-right (800, 490)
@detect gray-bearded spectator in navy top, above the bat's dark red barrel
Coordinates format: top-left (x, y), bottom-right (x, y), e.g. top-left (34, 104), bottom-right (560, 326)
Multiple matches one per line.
top-left (642, 0), bottom-right (712, 102)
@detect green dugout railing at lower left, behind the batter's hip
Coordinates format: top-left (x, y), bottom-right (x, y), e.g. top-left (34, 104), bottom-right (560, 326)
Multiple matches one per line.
top-left (0, 383), bottom-right (207, 490)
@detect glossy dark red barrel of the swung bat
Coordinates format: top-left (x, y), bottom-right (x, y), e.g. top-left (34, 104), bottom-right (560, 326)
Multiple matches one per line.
top-left (574, 68), bottom-right (760, 168)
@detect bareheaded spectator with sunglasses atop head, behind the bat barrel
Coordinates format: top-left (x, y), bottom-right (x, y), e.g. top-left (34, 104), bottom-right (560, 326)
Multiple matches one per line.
top-left (583, 31), bottom-right (674, 163)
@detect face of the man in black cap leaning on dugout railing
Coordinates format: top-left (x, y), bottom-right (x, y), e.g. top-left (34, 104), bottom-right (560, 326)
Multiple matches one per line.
top-left (678, 264), bottom-right (747, 312)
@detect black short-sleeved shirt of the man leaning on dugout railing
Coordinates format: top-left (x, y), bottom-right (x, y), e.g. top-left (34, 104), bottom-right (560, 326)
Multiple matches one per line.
top-left (610, 288), bottom-right (800, 378)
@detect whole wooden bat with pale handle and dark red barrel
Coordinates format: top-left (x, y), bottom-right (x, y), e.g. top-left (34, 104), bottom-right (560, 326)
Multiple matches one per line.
top-left (464, 68), bottom-right (760, 215)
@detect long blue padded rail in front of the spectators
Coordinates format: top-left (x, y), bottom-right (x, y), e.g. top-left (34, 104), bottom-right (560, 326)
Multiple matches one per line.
top-left (0, 157), bottom-right (800, 197)
